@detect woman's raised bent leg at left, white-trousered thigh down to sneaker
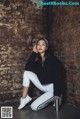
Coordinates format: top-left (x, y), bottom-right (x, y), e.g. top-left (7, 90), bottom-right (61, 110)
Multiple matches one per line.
top-left (18, 71), bottom-right (46, 109)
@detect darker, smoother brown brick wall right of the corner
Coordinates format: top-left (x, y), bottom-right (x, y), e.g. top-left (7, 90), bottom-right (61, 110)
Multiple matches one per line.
top-left (48, 6), bottom-right (80, 107)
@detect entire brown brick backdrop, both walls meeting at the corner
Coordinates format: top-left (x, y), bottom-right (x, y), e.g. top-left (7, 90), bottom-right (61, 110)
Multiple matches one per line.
top-left (0, 0), bottom-right (80, 107)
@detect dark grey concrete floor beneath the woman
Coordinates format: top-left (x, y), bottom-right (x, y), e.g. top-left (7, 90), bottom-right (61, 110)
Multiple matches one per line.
top-left (0, 102), bottom-right (80, 119)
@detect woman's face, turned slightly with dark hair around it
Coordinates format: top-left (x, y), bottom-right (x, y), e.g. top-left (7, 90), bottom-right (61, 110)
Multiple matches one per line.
top-left (37, 40), bottom-right (48, 53)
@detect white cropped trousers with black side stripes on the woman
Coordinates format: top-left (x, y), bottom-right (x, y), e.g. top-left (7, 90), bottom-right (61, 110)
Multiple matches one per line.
top-left (23, 71), bottom-right (54, 110)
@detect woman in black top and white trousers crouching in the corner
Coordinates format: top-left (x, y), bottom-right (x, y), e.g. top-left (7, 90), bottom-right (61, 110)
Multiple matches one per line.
top-left (18, 38), bottom-right (62, 111)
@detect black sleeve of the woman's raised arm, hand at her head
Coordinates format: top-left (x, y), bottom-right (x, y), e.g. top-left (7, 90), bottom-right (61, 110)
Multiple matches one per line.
top-left (25, 51), bottom-right (37, 70)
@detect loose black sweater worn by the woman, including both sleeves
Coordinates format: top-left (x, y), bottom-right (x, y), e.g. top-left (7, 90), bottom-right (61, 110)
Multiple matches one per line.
top-left (25, 52), bottom-right (63, 96)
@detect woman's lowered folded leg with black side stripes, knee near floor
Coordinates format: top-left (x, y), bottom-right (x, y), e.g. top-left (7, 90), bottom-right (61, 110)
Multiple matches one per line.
top-left (31, 84), bottom-right (54, 111)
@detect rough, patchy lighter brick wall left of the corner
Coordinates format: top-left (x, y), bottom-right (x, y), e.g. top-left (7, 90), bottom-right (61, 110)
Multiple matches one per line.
top-left (0, 0), bottom-right (46, 101)
